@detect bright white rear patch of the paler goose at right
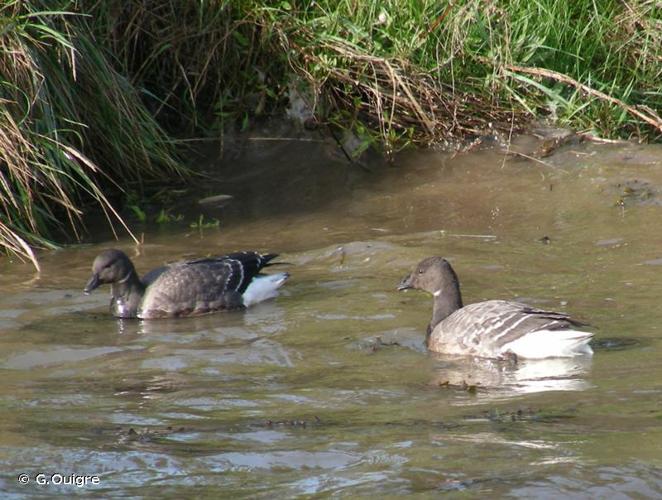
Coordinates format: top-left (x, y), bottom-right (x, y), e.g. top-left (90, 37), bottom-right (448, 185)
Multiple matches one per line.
top-left (501, 330), bottom-right (593, 359)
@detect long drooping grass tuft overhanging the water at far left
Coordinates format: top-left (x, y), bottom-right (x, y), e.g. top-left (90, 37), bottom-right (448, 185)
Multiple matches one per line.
top-left (0, 0), bottom-right (184, 268)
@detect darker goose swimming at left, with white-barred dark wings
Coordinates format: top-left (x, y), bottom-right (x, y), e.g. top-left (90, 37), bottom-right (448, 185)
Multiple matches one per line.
top-left (84, 249), bottom-right (289, 319)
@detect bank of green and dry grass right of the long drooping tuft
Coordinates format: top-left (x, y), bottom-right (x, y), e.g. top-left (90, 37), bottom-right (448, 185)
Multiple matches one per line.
top-left (100, 0), bottom-right (662, 148)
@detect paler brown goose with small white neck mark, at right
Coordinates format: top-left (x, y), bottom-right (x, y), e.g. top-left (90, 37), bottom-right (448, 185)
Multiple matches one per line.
top-left (398, 257), bottom-right (593, 359)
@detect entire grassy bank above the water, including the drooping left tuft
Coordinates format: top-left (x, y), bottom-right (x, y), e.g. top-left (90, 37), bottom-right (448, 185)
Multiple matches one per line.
top-left (0, 0), bottom-right (662, 264)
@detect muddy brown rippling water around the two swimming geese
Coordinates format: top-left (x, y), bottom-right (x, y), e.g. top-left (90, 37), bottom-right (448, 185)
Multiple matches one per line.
top-left (0, 134), bottom-right (662, 498)
